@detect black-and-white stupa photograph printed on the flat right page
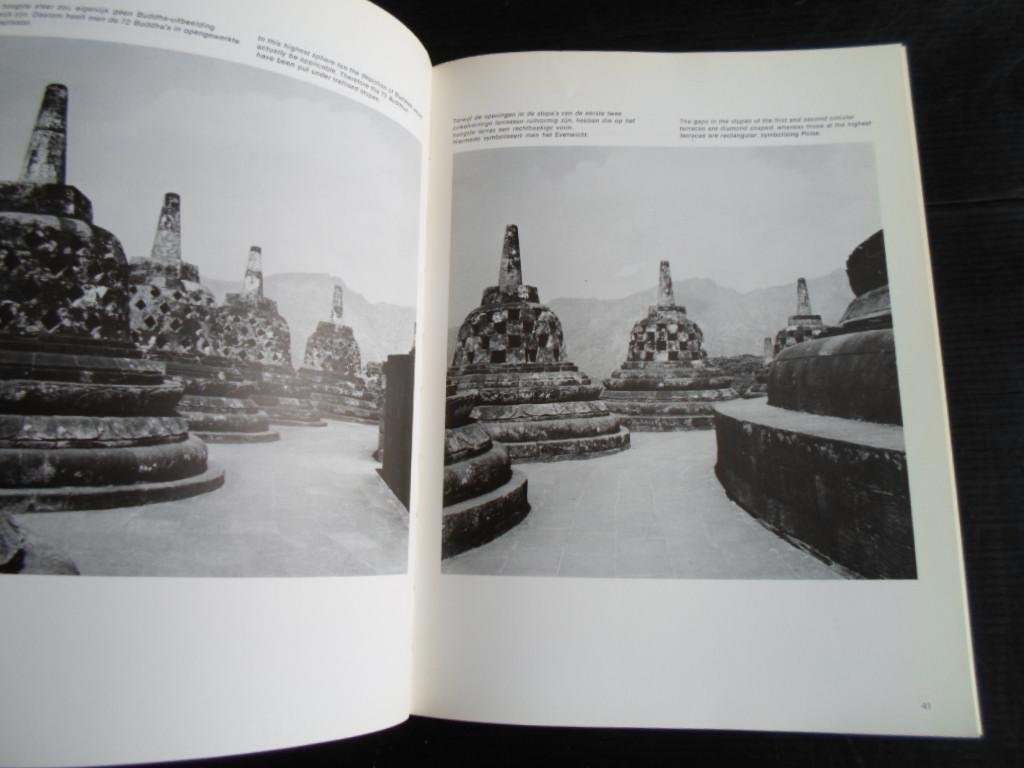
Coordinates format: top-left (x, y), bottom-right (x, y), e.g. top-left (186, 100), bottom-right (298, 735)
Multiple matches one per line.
top-left (441, 143), bottom-right (918, 580)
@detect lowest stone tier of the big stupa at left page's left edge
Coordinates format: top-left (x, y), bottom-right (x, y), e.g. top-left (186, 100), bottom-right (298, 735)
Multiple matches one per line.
top-left (0, 466), bottom-right (224, 513)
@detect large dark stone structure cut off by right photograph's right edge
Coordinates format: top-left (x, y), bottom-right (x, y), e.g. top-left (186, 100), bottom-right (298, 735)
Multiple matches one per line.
top-left (715, 231), bottom-right (916, 579)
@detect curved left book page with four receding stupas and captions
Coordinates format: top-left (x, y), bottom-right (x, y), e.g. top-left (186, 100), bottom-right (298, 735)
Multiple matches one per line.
top-left (0, 0), bottom-right (431, 765)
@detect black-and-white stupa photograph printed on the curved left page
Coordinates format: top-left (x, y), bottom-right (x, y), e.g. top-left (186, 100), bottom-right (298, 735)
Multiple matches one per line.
top-left (0, 38), bottom-right (422, 577)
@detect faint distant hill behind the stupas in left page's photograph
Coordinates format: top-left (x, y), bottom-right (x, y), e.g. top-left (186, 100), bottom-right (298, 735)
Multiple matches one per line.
top-left (203, 272), bottom-right (416, 369)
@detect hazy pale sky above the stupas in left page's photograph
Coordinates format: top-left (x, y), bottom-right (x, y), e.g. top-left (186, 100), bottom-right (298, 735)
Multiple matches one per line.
top-left (0, 37), bottom-right (420, 305)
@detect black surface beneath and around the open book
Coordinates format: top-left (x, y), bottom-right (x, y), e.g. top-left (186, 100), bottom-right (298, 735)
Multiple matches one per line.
top-left (188, 0), bottom-right (1024, 766)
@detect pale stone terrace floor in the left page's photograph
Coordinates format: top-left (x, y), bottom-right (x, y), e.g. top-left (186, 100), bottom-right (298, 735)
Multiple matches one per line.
top-left (15, 422), bottom-right (409, 577)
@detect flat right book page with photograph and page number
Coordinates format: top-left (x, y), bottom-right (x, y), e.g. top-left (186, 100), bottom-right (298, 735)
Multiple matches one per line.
top-left (414, 46), bottom-right (980, 736)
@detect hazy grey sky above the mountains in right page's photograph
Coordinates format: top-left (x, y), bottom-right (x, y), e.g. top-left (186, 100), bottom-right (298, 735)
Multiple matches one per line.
top-left (452, 143), bottom-right (882, 324)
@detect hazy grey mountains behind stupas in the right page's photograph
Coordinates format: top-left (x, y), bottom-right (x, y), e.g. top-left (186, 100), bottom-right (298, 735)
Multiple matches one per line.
top-left (449, 269), bottom-right (853, 379)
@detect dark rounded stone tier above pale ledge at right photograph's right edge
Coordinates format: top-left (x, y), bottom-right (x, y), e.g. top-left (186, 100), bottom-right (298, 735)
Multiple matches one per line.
top-left (768, 329), bottom-right (903, 424)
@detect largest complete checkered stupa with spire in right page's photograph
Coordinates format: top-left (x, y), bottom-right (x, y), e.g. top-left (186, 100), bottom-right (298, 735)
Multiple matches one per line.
top-left (449, 224), bottom-right (630, 461)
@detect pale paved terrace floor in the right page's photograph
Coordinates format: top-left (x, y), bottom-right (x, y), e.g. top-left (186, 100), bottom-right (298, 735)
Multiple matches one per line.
top-left (442, 430), bottom-right (844, 579)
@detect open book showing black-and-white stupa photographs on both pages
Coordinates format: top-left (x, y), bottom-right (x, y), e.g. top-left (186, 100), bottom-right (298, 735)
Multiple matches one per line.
top-left (0, 0), bottom-right (980, 764)
